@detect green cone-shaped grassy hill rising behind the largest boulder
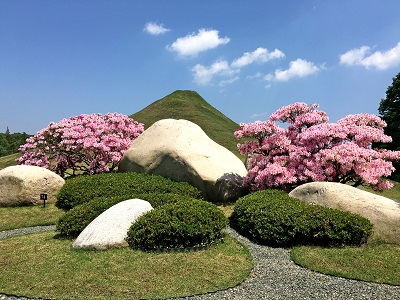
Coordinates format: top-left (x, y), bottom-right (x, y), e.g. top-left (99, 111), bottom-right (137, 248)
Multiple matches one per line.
top-left (130, 90), bottom-right (243, 158)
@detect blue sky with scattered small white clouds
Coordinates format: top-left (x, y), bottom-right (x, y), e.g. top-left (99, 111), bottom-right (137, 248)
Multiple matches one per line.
top-left (0, 0), bottom-right (400, 134)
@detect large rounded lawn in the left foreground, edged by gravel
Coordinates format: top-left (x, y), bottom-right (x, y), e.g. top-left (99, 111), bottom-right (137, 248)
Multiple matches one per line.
top-left (0, 232), bottom-right (253, 299)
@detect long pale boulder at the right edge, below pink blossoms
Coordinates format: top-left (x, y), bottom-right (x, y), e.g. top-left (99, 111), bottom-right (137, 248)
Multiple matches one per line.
top-left (289, 182), bottom-right (400, 244)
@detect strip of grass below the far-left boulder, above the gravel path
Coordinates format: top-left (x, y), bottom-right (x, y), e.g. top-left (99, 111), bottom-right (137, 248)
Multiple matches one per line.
top-left (0, 204), bottom-right (64, 231)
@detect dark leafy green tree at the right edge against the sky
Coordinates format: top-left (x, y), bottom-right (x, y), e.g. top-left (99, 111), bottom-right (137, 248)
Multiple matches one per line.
top-left (378, 73), bottom-right (400, 151)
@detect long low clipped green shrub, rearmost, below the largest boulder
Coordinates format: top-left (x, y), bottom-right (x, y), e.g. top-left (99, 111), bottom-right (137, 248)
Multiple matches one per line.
top-left (56, 172), bottom-right (202, 210)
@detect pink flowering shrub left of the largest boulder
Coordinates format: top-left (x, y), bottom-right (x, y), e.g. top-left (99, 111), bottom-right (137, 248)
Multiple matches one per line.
top-left (18, 113), bottom-right (144, 177)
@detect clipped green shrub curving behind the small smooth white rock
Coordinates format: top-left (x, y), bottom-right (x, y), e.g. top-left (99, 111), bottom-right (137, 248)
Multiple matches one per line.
top-left (56, 193), bottom-right (195, 238)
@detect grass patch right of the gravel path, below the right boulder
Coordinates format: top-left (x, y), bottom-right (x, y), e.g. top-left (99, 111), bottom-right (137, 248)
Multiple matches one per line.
top-left (291, 242), bottom-right (400, 285)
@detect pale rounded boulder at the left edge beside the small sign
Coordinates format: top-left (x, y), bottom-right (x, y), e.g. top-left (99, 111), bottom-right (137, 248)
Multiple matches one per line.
top-left (0, 165), bottom-right (65, 207)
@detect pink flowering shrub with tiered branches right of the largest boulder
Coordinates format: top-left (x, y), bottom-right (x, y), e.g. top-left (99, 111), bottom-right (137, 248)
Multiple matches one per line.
top-left (235, 103), bottom-right (400, 190)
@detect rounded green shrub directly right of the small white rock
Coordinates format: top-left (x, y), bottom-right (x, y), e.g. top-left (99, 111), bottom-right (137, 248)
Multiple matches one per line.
top-left (127, 200), bottom-right (228, 251)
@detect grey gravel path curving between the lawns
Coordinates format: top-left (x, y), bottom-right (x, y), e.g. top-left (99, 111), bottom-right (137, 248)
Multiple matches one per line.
top-left (0, 226), bottom-right (400, 300)
